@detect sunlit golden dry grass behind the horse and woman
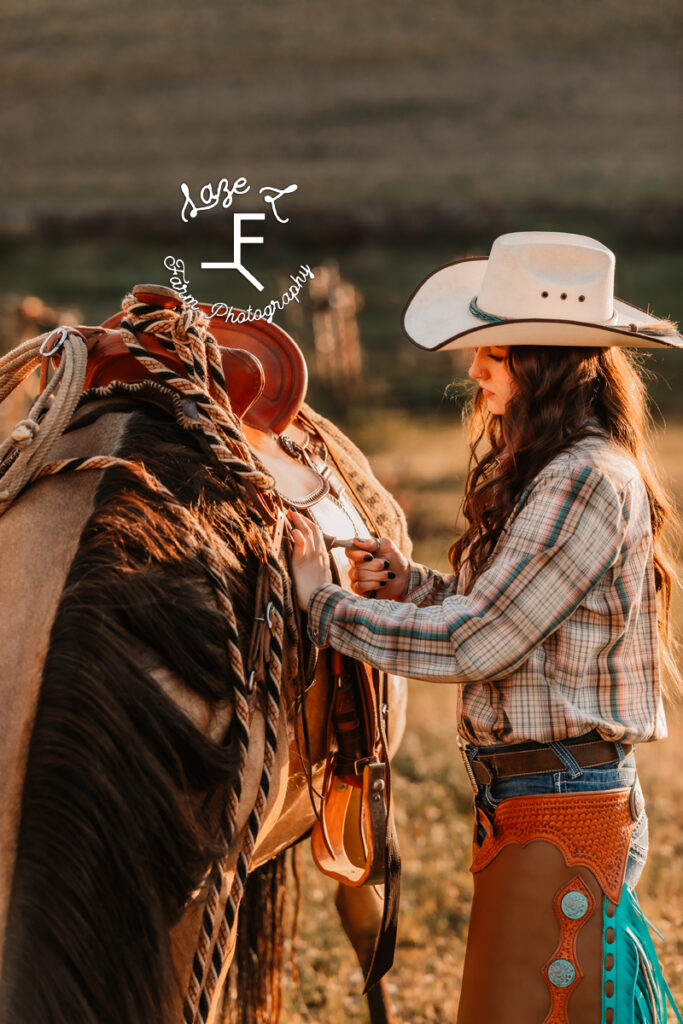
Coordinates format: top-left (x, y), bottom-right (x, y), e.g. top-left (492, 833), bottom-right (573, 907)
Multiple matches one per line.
top-left (283, 418), bottom-right (683, 1024)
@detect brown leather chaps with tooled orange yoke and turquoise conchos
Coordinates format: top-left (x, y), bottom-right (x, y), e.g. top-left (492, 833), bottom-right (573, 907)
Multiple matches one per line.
top-left (458, 790), bottom-right (637, 1024)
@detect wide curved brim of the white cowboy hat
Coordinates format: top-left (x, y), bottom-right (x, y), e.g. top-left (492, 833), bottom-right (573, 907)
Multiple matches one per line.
top-left (401, 258), bottom-right (683, 351)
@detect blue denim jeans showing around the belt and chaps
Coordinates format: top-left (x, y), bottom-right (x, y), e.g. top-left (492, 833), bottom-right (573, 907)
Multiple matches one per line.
top-left (465, 742), bottom-right (648, 889)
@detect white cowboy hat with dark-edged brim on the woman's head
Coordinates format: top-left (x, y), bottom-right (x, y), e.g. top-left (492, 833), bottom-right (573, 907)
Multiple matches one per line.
top-left (401, 231), bottom-right (683, 350)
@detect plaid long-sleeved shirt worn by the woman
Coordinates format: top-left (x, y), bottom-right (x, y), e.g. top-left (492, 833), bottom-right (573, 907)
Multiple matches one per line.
top-left (308, 437), bottom-right (667, 743)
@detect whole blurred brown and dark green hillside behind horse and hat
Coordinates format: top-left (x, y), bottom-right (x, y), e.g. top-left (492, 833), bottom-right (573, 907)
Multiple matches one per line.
top-left (0, 0), bottom-right (683, 418)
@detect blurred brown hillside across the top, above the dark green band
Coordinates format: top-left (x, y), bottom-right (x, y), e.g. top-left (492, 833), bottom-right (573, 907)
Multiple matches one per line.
top-left (0, 0), bottom-right (681, 225)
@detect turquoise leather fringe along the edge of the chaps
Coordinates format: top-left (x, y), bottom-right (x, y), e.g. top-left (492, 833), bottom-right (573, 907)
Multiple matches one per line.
top-left (602, 886), bottom-right (683, 1024)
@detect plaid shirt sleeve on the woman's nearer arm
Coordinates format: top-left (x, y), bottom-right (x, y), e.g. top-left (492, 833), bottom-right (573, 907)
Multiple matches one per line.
top-left (308, 466), bottom-right (628, 683)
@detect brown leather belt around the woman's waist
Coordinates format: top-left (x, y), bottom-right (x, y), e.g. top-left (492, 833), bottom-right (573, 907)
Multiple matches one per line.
top-left (472, 739), bottom-right (633, 785)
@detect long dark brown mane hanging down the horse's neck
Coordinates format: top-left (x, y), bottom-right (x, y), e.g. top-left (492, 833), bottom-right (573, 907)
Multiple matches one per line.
top-left (0, 408), bottom-right (264, 1024)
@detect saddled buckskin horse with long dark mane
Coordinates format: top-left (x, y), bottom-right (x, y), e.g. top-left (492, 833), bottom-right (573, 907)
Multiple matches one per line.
top-left (0, 286), bottom-right (410, 1024)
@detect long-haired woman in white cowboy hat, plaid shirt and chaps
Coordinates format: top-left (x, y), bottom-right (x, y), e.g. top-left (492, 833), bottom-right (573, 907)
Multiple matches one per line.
top-left (292, 232), bottom-right (683, 1024)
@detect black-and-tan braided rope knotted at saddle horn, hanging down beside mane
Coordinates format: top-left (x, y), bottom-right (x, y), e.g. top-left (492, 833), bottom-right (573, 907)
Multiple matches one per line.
top-left (113, 295), bottom-right (285, 1024)
